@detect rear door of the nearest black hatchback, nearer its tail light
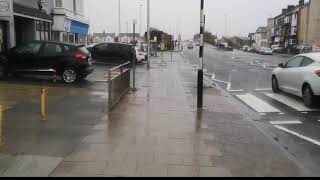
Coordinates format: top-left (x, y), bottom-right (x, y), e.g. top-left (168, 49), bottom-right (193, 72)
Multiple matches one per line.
top-left (38, 42), bottom-right (63, 71)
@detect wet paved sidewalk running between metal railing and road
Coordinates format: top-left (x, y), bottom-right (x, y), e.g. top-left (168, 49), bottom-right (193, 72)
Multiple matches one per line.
top-left (50, 53), bottom-right (305, 177)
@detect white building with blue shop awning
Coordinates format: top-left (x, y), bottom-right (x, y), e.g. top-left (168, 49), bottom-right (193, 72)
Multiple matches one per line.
top-left (52, 0), bottom-right (89, 44)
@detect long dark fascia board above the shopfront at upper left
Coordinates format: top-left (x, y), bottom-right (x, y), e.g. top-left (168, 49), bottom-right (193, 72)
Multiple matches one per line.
top-left (13, 3), bottom-right (52, 21)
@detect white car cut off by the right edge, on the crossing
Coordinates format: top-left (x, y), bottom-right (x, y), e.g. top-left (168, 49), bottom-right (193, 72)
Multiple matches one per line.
top-left (272, 53), bottom-right (320, 108)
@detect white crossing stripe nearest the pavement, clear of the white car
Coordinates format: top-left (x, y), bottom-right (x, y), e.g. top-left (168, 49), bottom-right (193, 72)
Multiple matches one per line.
top-left (236, 94), bottom-right (281, 113)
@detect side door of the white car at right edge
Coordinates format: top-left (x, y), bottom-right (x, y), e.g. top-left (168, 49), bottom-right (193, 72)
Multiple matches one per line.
top-left (279, 56), bottom-right (304, 95)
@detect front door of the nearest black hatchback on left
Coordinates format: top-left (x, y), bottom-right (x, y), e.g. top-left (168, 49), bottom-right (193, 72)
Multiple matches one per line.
top-left (9, 42), bottom-right (42, 72)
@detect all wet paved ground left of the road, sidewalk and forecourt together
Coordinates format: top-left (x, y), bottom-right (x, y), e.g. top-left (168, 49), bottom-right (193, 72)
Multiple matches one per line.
top-left (0, 53), bottom-right (306, 177)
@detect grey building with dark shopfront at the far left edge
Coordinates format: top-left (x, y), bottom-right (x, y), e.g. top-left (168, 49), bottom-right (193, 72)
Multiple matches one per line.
top-left (0, 0), bottom-right (52, 51)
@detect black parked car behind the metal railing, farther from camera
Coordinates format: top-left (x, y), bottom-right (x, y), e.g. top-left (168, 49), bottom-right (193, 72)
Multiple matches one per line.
top-left (87, 43), bottom-right (136, 65)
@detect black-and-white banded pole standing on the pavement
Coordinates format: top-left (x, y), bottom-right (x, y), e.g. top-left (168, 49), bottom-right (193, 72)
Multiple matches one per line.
top-left (197, 0), bottom-right (205, 109)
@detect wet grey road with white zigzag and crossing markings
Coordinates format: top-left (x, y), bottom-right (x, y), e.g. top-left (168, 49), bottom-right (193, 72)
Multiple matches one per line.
top-left (183, 46), bottom-right (320, 174)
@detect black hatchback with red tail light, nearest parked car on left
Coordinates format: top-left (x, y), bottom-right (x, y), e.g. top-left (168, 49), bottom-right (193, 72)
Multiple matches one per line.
top-left (0, 41), bottom-right (94, 84)
